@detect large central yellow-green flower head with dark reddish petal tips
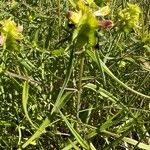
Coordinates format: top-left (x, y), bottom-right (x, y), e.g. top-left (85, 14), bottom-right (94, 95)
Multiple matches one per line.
top-left (67, 0), bottom-right (113, 47)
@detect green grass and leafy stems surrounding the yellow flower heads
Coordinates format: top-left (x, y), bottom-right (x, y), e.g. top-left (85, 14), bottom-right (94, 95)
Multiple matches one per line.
top-left (0, 0), bottom-right (150, 150)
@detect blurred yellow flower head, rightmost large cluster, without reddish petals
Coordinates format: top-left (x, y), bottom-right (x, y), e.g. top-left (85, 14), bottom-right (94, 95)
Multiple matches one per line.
top-left (117, 3), bottom-right (141, 32)
